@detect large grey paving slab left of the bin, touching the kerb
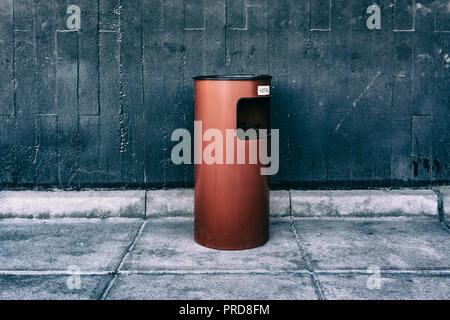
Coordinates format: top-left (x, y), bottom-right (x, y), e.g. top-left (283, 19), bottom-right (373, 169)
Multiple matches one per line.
top-left (0, 219), bottom-right (142, 272)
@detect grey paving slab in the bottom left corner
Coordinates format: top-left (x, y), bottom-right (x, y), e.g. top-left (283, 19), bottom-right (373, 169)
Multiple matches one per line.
top-left (0, 275), bottom-right (112, 300)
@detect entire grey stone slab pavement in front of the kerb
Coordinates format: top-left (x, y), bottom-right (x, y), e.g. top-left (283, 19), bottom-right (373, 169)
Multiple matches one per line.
top-left (0, 216), bottom-right (450, 299)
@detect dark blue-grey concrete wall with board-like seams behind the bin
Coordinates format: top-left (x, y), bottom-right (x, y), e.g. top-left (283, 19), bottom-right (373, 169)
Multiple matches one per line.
top-left (0, 0), bottom-right (450, 188)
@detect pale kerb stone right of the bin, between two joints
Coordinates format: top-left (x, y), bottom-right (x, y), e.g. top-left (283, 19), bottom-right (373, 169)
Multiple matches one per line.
top-left (291, 190), bottom-right (438, 217)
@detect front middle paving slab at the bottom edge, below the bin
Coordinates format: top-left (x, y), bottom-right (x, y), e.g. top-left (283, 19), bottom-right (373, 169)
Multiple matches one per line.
top-left (107, 274), bottom-right (317, 300)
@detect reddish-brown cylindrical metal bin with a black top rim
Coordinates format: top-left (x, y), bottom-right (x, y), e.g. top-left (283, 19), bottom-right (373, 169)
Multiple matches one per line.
top-left (194, 75), bottom-right (272, 250)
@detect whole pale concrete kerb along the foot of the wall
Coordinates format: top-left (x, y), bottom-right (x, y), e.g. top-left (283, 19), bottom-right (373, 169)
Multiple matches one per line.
top-left (0, 187), bottom-right (450, 220)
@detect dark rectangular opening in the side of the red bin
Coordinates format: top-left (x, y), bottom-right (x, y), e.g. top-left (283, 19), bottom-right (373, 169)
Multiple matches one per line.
top-left (236, 97), bottom-right (270, 140)
